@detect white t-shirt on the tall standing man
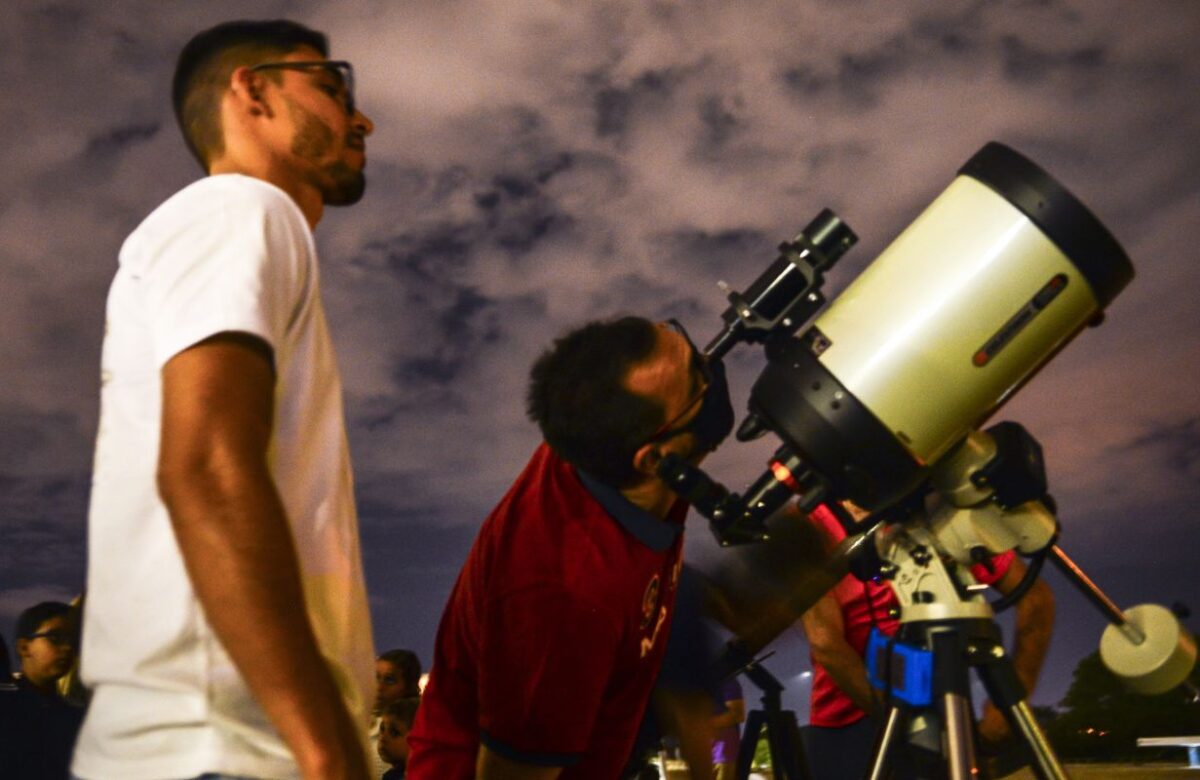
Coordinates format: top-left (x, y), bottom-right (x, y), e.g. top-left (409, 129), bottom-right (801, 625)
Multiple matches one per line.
top-left (72, 175), bottom-right (374, 780)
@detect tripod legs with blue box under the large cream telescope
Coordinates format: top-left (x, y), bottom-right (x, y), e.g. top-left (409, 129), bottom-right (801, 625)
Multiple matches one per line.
top-left (868, 618), bottom-right (1067, 780)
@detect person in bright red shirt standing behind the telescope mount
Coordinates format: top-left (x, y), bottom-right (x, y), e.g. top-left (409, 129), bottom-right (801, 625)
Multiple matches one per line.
top-left (800, 506), bottom-right (1054, 780)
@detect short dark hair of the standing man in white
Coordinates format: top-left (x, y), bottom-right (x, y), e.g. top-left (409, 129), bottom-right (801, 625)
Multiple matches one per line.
top-left (170, 19), bottom-right (329, 166)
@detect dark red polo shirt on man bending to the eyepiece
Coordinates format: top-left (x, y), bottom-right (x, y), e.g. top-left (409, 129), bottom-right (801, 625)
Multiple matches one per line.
top-left (407, 444), bottom-right (686, 780)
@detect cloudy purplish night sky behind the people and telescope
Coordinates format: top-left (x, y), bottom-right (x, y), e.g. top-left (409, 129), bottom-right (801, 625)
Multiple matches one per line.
top-left (0, 0), bottom-right (1200, 721)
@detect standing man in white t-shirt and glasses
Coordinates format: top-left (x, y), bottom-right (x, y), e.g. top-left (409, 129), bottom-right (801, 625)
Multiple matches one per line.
top-left (72, 20), bottom-right (374, 780)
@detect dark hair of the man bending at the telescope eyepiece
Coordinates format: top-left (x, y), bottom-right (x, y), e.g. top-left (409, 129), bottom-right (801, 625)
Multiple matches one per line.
top-left (526, 317), bottom-right (666, 487)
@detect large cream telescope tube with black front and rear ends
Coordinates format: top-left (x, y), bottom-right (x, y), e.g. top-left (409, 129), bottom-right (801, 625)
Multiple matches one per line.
top-left (744, 143), bottom-right (1133, 511)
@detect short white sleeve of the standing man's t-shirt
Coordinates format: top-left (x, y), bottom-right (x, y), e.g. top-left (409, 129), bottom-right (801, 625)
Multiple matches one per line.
top-left (139, 183), bottom-right (311, 368)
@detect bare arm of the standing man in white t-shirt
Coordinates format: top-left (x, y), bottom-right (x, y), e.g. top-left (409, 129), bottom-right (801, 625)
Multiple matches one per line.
top-left (158, 334), bottom-right (367, 780)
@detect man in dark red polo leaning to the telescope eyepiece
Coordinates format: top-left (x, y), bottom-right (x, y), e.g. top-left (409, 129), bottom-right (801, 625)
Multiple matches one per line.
top-left (408, 317), bottom-right (733, 780)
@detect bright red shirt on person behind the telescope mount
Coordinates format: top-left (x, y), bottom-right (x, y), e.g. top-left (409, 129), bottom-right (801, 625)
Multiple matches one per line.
top-left (809, 505), bottom-right (1013, 728)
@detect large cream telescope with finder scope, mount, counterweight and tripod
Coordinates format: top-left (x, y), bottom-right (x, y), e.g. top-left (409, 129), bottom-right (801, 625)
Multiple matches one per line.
top-left (659, 143), bottom-right (1196, 778)
